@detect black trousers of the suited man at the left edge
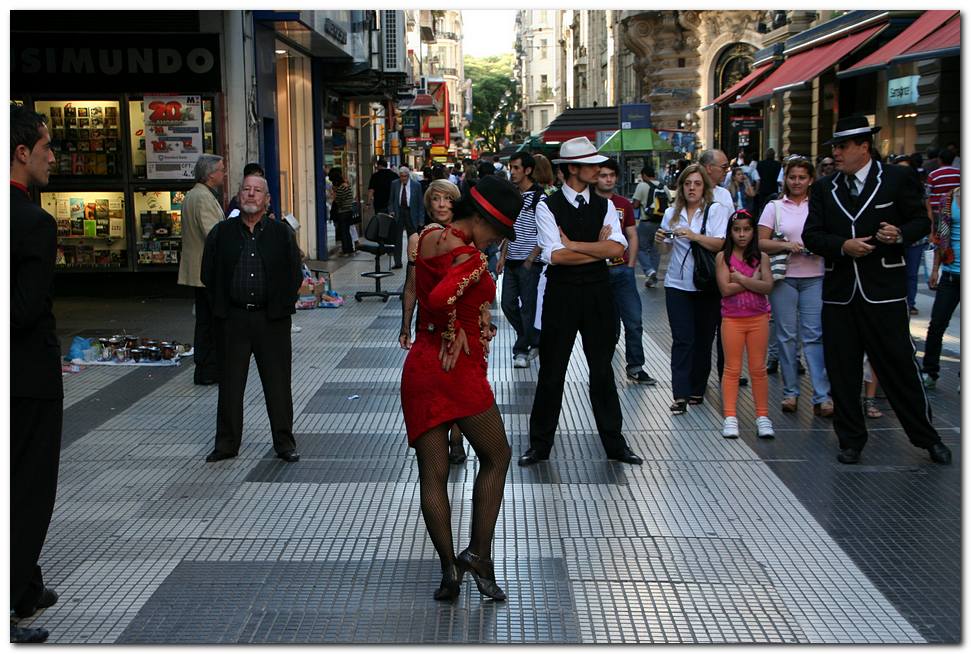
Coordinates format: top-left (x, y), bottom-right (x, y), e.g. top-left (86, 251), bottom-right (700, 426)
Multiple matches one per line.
top-left (10, 397), bottom-right (64, 611)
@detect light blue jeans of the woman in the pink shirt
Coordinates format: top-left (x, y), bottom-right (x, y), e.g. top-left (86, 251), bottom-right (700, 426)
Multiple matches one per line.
top-left (769, 277), bottom-right (830, 404)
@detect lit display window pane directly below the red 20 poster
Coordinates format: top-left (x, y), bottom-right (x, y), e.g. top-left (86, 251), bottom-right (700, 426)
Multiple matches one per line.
top-left (133, 191), bottom-right (185, 268)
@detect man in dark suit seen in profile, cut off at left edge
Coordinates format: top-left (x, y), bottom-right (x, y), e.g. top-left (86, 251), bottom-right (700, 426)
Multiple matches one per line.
top-left (9, 106), bottom-right (64, 643)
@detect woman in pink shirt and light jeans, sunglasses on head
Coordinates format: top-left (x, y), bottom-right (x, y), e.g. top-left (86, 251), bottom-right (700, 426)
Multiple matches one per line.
top-left (759, 156), bottom-right (833, 418)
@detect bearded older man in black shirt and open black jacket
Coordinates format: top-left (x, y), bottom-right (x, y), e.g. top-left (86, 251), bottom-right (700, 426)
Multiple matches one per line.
top-left (202, 175), bottom-right (303, 463)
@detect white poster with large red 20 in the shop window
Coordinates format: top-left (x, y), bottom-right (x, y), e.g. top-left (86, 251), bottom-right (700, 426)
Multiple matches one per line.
top-left (145, 95), bottom-right (202, 179)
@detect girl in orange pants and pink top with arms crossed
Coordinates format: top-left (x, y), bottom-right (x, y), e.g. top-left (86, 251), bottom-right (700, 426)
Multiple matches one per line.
top-left (715, 210), bottom-right (775, 438)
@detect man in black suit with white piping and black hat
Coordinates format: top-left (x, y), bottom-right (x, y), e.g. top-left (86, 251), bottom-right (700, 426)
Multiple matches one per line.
top-left (802, 116), bottom-right (951, 464)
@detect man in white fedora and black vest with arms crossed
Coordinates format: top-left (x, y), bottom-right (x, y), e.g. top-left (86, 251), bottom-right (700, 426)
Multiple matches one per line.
top-left (519, 137), bottom-right (643, 466)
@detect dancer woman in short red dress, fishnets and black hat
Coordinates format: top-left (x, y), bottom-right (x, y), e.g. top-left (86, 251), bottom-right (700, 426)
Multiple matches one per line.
top-left (401, 176), bottom-right (522, 601)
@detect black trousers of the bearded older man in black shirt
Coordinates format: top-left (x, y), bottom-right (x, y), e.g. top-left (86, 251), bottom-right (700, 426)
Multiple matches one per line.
top-left (216, 307), bottom-right (296, 455)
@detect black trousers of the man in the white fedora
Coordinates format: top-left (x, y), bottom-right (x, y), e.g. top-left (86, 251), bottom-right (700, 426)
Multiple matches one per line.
top-left (529, 280), bottom-right (627, 457)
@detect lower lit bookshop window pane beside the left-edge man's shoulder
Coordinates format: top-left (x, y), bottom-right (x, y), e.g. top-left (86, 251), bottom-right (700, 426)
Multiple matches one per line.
top-left (40, 191), bottom-right (128, 268)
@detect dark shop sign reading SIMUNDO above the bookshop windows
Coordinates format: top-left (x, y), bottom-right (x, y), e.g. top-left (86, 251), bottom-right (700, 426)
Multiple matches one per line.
top-left (10, 32), bottom-right (221, 94)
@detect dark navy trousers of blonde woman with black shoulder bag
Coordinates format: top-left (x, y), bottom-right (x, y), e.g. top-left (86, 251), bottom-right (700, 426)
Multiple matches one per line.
top-left (664, 288), bottom-right (721, 400)
